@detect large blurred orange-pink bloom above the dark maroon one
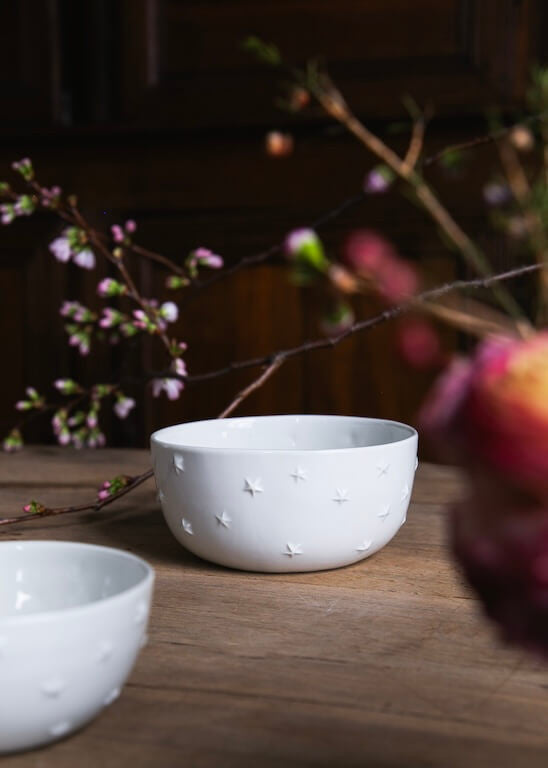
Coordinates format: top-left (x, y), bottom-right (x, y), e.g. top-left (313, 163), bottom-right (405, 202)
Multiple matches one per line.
top-left (421, 332), bottom-right (548, 499)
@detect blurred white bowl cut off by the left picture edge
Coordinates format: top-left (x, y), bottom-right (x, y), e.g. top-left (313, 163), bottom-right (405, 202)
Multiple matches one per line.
top-left (0, 541), bottom-right (154, 754)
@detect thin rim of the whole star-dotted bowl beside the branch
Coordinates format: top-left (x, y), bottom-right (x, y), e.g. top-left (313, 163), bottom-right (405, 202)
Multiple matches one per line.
top-left (150, 413), bottom-right (418, 455)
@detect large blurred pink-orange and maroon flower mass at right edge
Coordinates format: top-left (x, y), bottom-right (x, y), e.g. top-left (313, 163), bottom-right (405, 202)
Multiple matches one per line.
top-left (421, 332), bottom-right (548, 656)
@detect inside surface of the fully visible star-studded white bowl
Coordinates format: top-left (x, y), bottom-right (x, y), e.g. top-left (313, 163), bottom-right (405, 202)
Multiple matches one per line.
top-left (152, 415), bottom-right (415, 451)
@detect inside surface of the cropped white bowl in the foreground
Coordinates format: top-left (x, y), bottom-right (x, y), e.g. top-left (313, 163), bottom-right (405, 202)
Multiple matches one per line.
top-left (0, 541), bottom-right (150, 619)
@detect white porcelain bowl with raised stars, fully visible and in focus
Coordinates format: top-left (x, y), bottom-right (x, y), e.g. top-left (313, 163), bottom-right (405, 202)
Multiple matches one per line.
top-left (151, 416), bottom-right (417, 572)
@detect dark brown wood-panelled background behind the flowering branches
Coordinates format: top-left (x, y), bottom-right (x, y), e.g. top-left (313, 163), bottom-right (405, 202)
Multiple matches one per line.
top-left (0, 0), bottom-right (548, 446)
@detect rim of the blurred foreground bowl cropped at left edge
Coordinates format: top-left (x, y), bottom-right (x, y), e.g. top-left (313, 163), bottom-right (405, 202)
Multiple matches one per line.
top-left (0, 539), bottom-right (156, 630)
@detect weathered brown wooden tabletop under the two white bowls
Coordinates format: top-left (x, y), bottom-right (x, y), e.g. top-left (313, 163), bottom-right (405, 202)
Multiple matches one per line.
top-left (0, 447), bottom-right (548, 768)
